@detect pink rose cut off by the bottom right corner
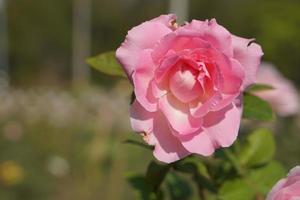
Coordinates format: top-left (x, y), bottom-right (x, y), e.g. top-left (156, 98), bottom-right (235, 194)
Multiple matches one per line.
top-left (267, 166), bottom-right (300, 200)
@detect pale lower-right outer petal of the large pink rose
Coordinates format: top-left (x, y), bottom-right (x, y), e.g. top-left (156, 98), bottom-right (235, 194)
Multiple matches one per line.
top-left (203, 99), bottom-right (242, 147)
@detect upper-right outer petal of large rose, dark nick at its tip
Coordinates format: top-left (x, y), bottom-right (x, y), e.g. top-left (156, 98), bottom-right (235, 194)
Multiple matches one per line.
top-left (232, 35), bottom-right (263, 88)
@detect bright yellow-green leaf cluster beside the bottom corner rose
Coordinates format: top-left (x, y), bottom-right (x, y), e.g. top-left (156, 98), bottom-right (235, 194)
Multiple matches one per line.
top-left (219, 129), bottom-right (285, 200)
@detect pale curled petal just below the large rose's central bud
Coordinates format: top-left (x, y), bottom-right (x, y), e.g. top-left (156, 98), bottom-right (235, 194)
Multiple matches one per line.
top-left (159, 93), bottom-right (202, 135)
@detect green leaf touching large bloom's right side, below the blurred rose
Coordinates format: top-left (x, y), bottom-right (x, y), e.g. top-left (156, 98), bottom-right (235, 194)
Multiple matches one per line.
top-left (243, 93), bottom-right (274, 121)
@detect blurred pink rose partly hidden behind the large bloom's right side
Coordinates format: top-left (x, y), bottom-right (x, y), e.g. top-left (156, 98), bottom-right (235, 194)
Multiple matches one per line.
top-left (254, 63), bottom-right (299, 116)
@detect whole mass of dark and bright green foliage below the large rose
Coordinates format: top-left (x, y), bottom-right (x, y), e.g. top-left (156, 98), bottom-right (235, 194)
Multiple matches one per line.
top-left (124, 126), bottom-right (285, 200)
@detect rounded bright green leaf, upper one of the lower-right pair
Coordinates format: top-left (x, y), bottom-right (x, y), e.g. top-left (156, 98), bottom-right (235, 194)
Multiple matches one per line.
top-left (239, 129), bottom-right (275, 167)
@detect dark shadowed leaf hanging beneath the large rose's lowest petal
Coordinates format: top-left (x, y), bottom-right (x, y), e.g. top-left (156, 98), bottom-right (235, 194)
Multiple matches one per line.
top-left (146, 161), bottom-right (170, 192)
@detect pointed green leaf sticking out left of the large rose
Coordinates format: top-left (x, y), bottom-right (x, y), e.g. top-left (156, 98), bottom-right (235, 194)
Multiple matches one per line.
top-left (87, 51), bottom-right (127, 77)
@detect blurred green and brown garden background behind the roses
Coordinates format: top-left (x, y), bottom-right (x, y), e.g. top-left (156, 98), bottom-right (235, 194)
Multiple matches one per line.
top-left (0, 0), bottom-right (300, 200)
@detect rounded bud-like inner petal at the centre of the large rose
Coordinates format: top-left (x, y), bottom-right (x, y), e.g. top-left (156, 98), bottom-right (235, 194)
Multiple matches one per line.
top-left (169, 62), bottom-right (203, 103)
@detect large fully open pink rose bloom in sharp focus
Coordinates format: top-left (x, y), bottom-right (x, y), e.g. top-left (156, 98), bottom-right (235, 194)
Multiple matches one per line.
top-left (116, 14), bottom-right (263, 163)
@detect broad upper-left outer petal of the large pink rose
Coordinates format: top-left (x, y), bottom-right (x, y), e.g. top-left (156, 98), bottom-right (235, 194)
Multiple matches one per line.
top-left (116, 15), bottom-right (176, 80)
